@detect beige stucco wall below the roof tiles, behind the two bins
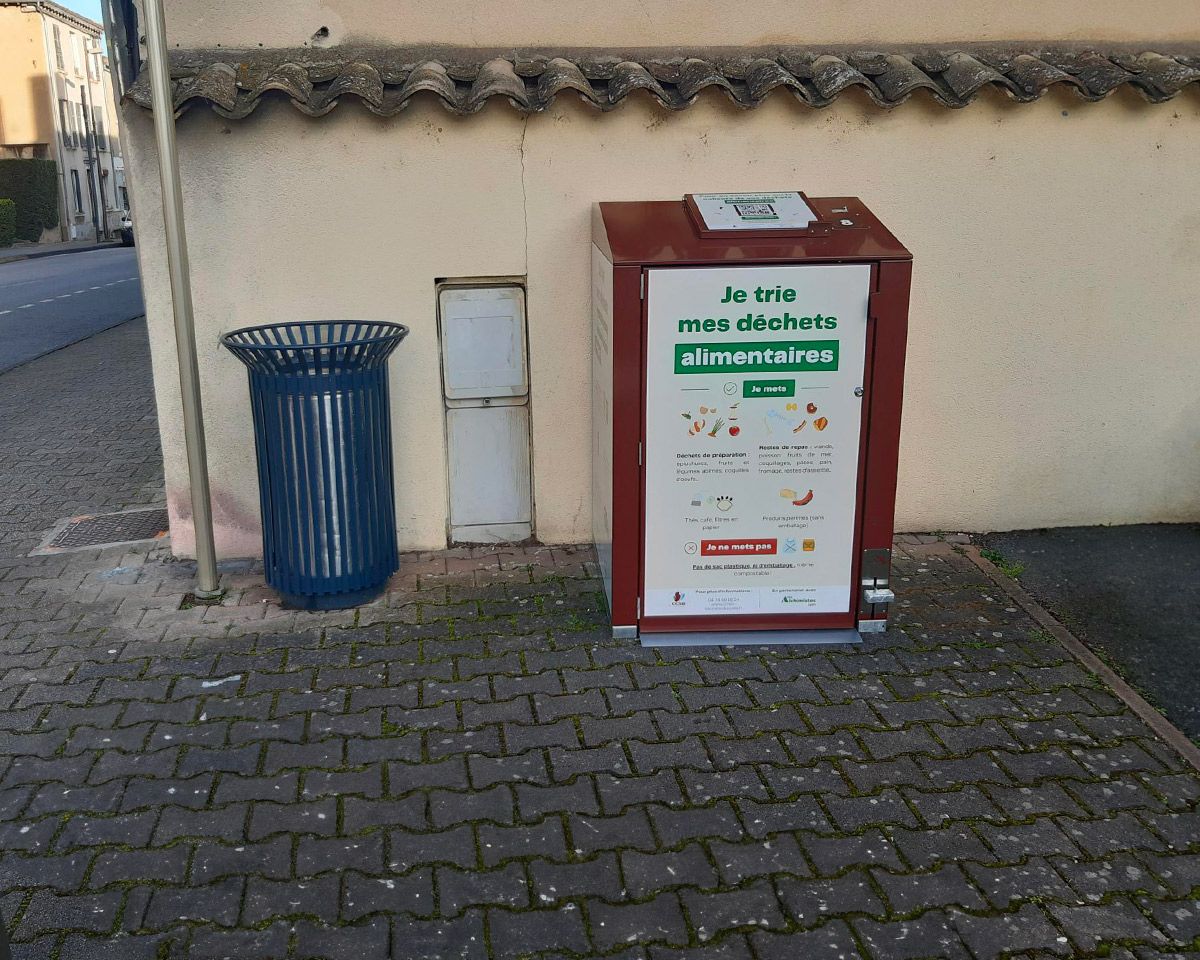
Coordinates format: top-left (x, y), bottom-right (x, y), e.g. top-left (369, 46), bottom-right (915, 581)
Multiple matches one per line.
top-left (126, 82), bottom-right (1200, 556)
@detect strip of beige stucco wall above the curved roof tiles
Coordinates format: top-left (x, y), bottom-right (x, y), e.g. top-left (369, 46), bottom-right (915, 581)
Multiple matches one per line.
top-left (168, 0), bottom-right (1200, 47)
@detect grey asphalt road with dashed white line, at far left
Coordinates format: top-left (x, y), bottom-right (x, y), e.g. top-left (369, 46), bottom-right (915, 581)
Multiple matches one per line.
top-left (0, 247), bottom-right (144, 373)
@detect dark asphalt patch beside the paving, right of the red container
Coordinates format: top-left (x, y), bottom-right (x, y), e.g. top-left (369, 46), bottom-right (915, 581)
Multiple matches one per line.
top-left (984, 523), bottom-right (1200, 742)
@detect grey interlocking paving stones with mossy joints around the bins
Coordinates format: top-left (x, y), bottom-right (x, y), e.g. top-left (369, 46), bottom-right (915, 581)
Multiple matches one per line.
top-left (0, 326), bottom-right (1200, 960)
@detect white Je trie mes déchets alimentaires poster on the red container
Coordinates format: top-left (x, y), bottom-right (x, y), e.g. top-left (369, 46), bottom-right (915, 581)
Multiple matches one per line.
top-left (643, 264), bottom-right (870, 617)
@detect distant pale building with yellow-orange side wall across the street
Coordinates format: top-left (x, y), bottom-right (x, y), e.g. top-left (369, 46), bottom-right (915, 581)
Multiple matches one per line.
top-left (0, 0), bottom-right (128, 240)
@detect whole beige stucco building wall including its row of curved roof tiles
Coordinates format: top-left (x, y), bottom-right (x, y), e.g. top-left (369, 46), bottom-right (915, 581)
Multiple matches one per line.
top-left (112, 0), bottom-right (1200, 556)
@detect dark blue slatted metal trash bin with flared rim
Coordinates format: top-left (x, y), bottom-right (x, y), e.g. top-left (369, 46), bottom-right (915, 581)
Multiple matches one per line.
top-left (221, 320), bottom-right (408, 610)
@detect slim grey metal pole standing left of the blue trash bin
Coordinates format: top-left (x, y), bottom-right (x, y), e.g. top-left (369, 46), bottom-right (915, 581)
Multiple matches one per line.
top-left (143, 0), bottom-right (221, 599)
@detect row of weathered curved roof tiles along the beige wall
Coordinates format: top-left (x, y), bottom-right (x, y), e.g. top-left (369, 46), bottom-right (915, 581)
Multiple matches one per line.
top-left (127, 44), bottom-right (1200, 119)
